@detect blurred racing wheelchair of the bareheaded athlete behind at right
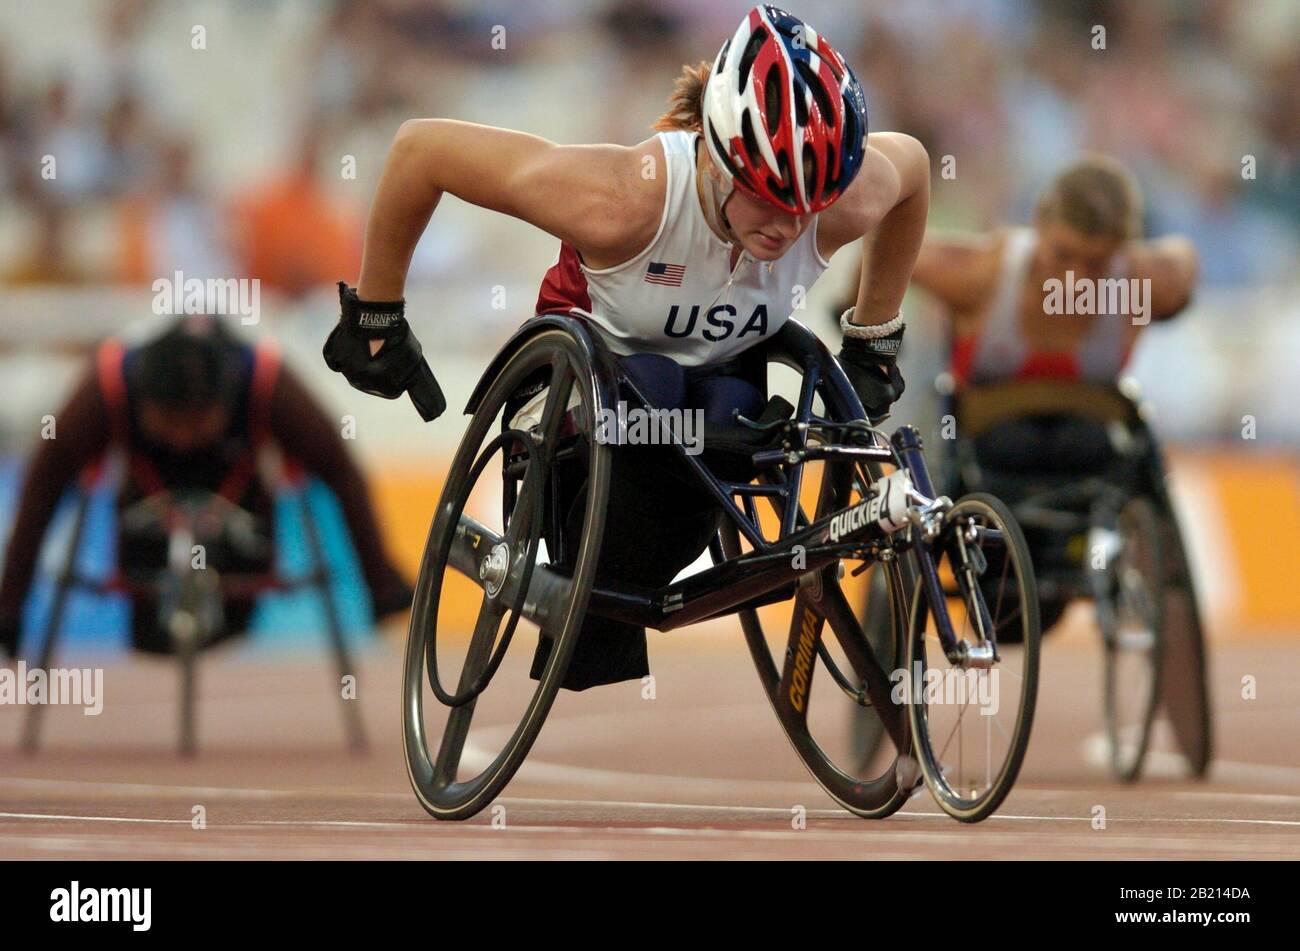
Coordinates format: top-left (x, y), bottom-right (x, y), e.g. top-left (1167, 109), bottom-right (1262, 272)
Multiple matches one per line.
top-left (940, 378), bottom-right (1212, 782)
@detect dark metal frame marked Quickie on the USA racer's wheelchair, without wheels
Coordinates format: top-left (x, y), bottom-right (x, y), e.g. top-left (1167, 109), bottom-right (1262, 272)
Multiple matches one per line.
top-left (426, 314), bottom-right (1034, 784)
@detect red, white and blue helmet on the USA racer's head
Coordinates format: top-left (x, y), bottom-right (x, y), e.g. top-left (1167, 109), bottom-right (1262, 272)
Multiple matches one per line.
top-left (703, 4), bottom-right (867, 214)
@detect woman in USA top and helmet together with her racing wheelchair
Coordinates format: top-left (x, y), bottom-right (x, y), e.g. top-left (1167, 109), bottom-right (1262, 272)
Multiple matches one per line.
top-left (325, 5), bottom-right (1037, 818)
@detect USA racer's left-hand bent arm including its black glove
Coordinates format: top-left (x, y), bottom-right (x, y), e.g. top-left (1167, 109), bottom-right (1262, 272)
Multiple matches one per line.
top-left (322, 120), bottom-right (650, 421)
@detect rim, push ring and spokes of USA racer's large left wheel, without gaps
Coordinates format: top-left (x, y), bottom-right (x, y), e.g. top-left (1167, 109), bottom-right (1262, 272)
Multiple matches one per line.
top-left (402, 329), bottom-right (610, 818)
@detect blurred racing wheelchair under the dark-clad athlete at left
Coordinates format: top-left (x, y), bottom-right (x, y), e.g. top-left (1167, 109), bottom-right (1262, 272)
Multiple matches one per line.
top-left (20, 452), bottom-right (368, 756)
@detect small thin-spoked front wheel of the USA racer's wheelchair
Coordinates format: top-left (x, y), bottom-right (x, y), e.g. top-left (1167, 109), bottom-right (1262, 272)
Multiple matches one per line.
top-left (905, 492), bottom-right (1041, 822)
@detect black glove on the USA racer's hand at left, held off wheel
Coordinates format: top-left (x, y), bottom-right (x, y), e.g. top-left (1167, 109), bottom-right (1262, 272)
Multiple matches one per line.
top-left (324, 281), bottom-right (447, 422)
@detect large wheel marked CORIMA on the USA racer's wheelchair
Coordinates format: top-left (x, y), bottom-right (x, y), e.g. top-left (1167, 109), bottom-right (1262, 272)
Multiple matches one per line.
top-left (714, 320), bottom-right (919, 818)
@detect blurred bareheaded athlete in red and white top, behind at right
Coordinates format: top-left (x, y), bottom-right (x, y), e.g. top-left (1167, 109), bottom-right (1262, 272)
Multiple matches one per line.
top-left (913, 156), bottom-right (1197, 392)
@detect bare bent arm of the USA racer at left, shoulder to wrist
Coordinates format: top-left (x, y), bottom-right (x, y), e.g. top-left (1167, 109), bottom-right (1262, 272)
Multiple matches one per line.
top-left (358, 118), bottom-right (650, 300)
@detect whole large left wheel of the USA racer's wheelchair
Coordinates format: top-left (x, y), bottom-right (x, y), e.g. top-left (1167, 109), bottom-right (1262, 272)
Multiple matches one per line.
top-left (402, 317), bottom-right (612, 820)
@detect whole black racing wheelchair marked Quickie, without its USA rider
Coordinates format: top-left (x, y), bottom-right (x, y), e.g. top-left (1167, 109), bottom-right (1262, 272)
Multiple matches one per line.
top-left (402, 314), bottom-right (1040, 822)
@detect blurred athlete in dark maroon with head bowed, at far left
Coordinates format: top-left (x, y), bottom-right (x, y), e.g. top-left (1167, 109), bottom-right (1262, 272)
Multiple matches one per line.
top-left (0, 318), bottom-right (411, 656)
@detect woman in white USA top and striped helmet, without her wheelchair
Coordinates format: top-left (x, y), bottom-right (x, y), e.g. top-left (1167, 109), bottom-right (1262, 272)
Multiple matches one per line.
top-left (325, 5), bottom-right (930, 686)
